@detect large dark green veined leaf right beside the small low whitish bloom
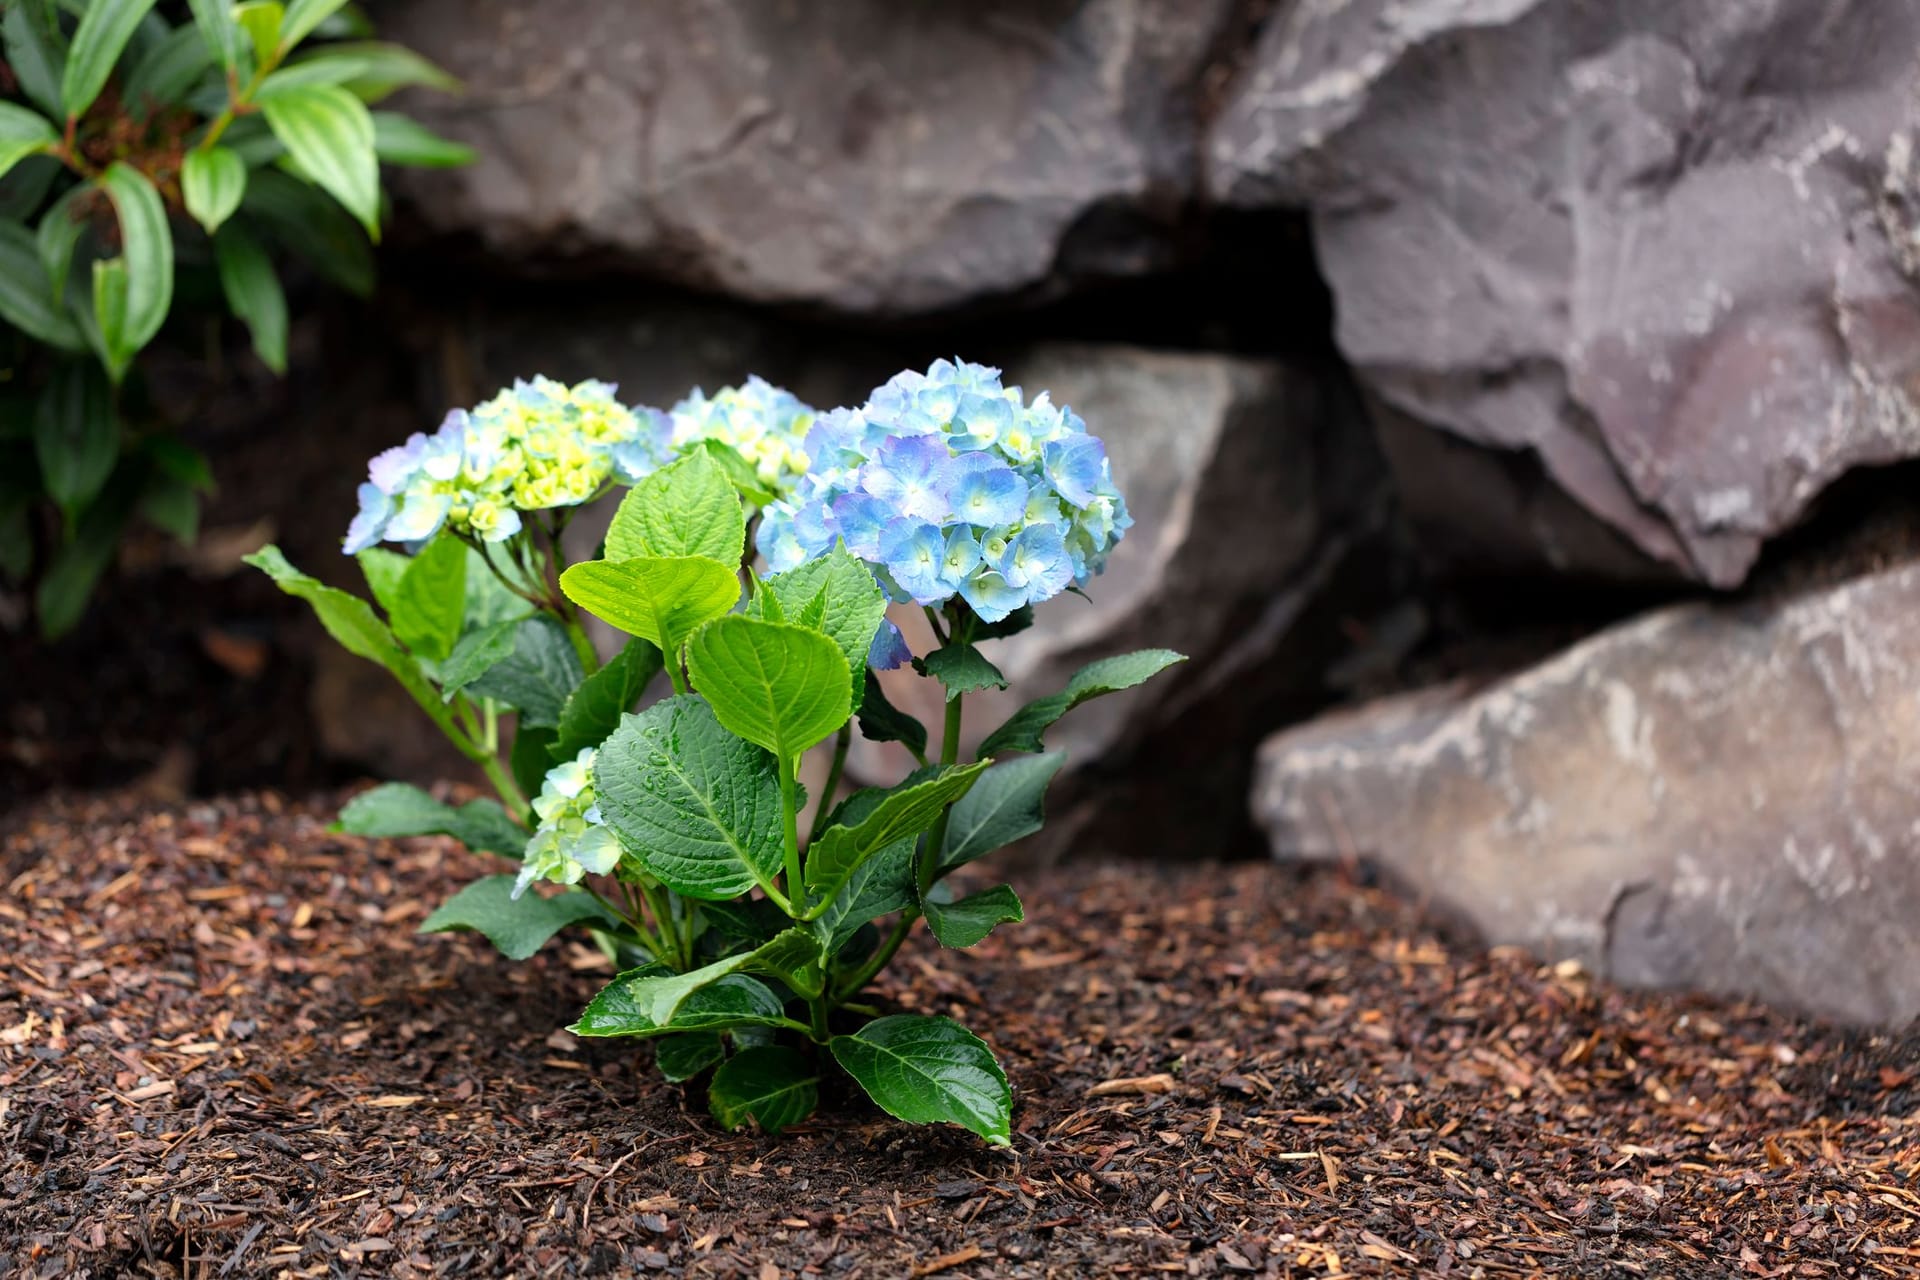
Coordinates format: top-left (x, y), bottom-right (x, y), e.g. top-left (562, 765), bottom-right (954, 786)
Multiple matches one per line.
top-left (593, 695), bottom-right (783, 900)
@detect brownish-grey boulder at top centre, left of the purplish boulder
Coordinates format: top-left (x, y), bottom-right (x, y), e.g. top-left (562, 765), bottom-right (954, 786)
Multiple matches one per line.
top-left (382, 0), bottom-right (1233, 311)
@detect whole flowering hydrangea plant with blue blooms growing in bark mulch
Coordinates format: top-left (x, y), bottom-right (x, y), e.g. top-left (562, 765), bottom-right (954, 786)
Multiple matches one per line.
top-left (253, 361), bottom-right (1181, 1144)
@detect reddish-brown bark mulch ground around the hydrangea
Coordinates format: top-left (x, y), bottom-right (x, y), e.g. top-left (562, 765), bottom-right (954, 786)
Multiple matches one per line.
top-left (0, 796), bottom-right (1920, 1280)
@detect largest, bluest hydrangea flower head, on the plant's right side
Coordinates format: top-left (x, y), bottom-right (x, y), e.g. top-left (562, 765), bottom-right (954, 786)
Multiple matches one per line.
top-left (756, 361), bottom-right (1133, 622)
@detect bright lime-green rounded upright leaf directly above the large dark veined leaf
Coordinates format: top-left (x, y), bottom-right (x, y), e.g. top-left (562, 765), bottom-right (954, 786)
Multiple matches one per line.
top-left (687, 616), bottom-right (852, 771)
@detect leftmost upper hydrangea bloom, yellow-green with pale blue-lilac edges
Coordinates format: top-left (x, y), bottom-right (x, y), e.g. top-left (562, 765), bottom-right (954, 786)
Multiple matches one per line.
top-left (344, 378), bottom-right (670, 555)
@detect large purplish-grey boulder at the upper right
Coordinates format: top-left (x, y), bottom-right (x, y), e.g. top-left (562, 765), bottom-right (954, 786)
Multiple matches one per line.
top-left (1208, 0), bottom-right (1920, 585)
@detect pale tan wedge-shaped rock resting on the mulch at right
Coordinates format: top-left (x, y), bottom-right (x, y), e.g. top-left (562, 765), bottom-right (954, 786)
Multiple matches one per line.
top-left (1254, 566), bottom-right (1920, 1023)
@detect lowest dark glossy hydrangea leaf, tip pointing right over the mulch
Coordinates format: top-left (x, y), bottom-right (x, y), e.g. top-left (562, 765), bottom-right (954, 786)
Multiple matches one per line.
top-left (831, 1013), bottom-right (1014, 1146)
